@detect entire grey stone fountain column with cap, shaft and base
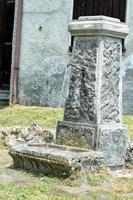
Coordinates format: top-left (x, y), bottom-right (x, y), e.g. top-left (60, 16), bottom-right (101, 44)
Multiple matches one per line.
top-left (56, 16), bottom-right (128, 167)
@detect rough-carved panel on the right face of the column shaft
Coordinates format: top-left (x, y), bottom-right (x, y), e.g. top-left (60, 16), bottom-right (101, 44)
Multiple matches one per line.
top-left (100, 38), bottom-right (122, 124)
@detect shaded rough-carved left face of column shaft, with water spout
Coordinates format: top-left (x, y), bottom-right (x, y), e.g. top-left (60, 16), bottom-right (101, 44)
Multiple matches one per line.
top-left (64, 37), bottom-right (99, 124)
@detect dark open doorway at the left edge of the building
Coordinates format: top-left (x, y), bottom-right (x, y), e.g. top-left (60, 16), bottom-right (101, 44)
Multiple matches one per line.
top-left (0, 0), bottom-right (15, 90)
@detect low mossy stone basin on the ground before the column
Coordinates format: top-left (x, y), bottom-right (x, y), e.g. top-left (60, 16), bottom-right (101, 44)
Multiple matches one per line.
top-left (9, 144), bottom-right (103, 177)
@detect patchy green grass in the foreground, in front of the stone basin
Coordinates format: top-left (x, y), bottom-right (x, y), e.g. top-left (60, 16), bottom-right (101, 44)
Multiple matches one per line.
top-left (0, 174), bottom-right (133, 200)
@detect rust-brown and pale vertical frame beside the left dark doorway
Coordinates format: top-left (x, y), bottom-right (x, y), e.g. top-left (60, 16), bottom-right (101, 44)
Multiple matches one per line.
top-left (9, 0), bottom-right (23, 104)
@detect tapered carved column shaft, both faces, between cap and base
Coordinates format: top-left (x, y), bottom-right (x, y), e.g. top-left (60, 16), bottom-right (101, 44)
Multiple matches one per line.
top-left (64, 36), bottom-right (122, 124)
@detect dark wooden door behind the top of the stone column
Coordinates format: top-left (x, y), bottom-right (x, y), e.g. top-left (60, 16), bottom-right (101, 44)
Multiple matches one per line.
top-left (73, 0), bottom-right (126, 22)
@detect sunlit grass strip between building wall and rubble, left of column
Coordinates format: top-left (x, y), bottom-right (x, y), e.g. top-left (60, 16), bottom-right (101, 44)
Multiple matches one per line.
top-left (0, 105), bottom-right (63, 128)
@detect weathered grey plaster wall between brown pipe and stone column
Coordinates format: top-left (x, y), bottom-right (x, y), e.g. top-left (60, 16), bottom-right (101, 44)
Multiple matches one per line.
top-left (18, 0), bottom-right (73, 107)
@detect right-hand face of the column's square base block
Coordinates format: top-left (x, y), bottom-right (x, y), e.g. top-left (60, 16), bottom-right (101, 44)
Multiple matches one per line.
top-left (96, 125), bottom-right (127, 169)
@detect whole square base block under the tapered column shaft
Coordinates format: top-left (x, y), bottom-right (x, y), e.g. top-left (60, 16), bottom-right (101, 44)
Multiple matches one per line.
top-left (56, 121), bottom-right (127, 168)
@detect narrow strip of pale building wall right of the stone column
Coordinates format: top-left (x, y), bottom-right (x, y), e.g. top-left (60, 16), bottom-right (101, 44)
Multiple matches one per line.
top-left (122, 0), bottom-right (133, 114)
